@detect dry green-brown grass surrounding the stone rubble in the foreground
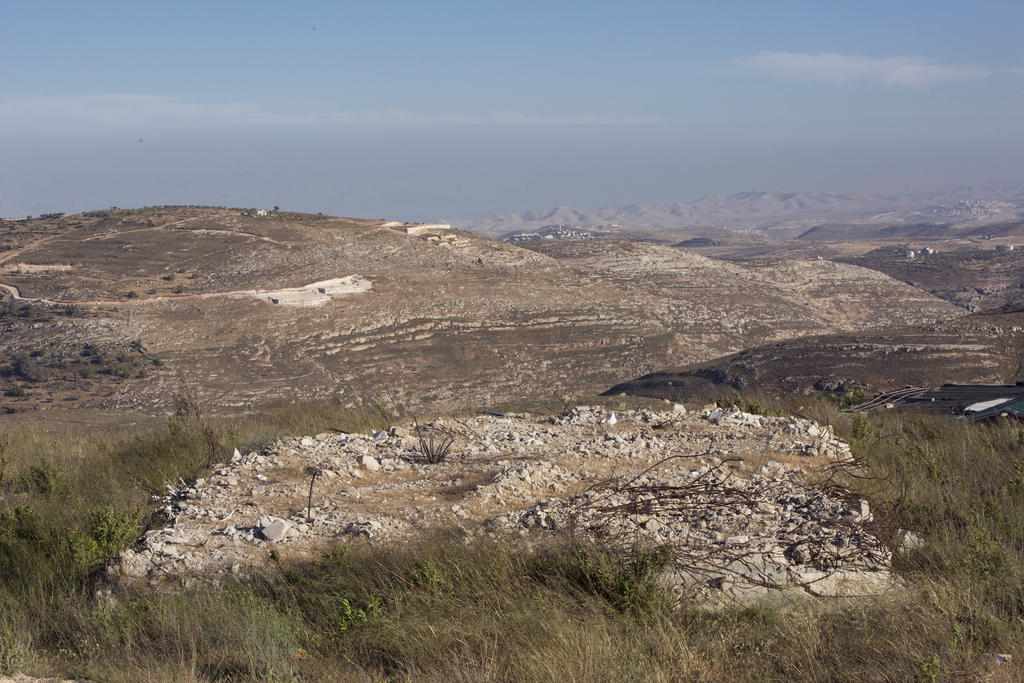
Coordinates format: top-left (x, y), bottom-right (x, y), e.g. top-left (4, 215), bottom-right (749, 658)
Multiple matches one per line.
top-left (0, 395), bottom-right (1024, 681)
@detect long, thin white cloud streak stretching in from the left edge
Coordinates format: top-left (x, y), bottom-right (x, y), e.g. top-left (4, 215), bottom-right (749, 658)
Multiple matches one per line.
top-left (0, 94), bottom-right (662, 131)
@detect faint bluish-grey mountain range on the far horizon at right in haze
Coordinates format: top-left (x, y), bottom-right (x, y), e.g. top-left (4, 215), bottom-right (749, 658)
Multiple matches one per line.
top-left (452, 186), bottom-right (1024, 238)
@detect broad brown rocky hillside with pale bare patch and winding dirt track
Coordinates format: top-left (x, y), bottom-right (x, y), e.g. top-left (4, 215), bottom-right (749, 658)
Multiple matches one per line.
top-left (0, 208), bottom-right (964, 411)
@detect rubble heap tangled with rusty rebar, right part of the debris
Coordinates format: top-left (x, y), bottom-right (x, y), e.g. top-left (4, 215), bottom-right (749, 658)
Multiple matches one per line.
top-left (487, 458), bottom-right (891, 600)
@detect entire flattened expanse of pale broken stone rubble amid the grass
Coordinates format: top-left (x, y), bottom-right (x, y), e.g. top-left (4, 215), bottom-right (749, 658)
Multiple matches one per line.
top-left (110, 404), bottom-right (893, 602)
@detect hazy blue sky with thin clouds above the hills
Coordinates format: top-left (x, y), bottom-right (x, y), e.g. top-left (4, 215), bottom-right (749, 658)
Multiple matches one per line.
top-left (0, 0), bottom-right (1024, 218)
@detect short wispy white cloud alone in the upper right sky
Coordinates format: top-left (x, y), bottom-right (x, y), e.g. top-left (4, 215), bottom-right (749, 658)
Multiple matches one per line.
top-left (729, 51), bottom-right (991, 87)
